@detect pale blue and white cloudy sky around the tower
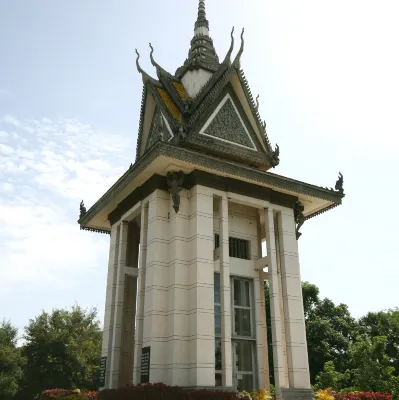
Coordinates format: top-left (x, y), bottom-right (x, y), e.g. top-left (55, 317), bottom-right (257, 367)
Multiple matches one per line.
top-left (0, 0), bottom-right (399, 338)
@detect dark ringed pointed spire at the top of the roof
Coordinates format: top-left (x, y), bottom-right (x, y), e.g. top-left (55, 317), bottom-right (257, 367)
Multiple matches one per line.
top-left (176, 0), bottom-right (220, 78)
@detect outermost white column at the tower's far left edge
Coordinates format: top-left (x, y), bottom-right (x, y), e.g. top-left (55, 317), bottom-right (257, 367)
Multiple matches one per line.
top-left (101, 225), bottom-right (119, 389)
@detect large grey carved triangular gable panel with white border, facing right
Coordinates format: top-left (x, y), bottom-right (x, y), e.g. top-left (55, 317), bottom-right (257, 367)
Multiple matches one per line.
top-left (200, 93), bottom-right (257, 151)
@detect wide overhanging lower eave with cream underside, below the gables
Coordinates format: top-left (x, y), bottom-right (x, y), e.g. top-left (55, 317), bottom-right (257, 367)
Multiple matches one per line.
top-left (78, 142), bottom-right (344, 231)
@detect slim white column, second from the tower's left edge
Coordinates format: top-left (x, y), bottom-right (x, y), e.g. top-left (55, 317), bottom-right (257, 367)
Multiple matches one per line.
top-left (110, 222), bottom-right (129, 389)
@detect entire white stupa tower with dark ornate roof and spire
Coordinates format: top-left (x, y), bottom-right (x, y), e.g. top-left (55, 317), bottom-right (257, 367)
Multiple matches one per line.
top-left (79, 0), bottom-right (344, 399)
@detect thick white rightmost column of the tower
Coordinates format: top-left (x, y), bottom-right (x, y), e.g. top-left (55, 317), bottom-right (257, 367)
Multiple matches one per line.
top-left (278, 209), bottom-right (311, 389)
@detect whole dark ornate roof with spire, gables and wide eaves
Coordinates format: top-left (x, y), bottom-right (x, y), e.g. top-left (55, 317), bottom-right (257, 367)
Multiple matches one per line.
top-left (79, 0), bottom-right (345, 237)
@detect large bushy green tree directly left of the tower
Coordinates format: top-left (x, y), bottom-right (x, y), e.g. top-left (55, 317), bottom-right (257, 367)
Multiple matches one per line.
top-left (19, 306), bottom-right (102, 399)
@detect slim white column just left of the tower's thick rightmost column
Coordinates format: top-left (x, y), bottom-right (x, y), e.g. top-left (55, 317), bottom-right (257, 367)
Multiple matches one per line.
top-left (265, 208), bottom-right (288, 400)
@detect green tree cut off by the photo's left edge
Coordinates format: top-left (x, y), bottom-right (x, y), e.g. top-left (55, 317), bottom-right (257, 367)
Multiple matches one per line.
top-left (0, 321), bottom-right (24, 400)
